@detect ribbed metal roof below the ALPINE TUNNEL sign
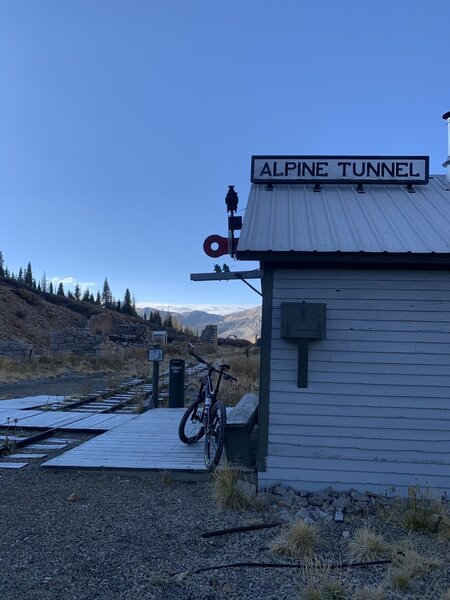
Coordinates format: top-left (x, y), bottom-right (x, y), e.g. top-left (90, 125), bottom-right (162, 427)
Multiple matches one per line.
top-left (237, 175), bottom-right (450, 257)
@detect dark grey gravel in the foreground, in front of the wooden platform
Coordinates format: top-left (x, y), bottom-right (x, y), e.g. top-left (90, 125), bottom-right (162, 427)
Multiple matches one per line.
top-left (0, 466), bottom-right (302, 600)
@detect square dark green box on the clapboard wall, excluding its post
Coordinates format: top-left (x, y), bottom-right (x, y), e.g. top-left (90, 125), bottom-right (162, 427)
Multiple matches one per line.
top-left (281, 302), bottom-right (327, 340)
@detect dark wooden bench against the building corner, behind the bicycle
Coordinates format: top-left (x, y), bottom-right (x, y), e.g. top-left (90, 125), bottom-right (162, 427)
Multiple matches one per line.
top-left (225, 394), bottom-right (259, 467)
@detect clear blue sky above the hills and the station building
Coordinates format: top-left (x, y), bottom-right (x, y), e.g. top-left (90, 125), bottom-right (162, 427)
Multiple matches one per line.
top-left (0, 0), bottom-right (450, 314)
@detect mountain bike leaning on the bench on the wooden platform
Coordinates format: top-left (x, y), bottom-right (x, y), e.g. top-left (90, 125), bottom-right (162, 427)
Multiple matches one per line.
top-left (178, 344), bottom-right (237, 470)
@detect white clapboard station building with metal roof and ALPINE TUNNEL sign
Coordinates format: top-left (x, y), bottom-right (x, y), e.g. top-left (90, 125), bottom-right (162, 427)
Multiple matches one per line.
top-left (237, 115), bottom-right (450, 494)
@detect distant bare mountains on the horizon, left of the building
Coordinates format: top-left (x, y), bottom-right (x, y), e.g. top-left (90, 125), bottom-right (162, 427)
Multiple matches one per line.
top-left (137, 306), bottom-right (261, 342)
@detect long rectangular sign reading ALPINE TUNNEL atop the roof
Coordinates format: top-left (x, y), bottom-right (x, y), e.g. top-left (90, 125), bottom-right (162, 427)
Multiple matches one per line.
top-left (251, 156), bottom-right (430, 185)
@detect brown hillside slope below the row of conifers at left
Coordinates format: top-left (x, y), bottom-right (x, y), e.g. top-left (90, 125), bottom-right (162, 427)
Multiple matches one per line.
top-left (0, 280), bottom-right (140, 353)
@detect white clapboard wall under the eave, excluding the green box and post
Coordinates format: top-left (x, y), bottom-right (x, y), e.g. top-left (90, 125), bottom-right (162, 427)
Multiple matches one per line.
top-left (259, 269), bottom-right (450, 494)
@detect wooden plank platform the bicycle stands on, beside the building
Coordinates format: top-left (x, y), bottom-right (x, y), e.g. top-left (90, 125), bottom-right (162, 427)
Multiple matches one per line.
top-left (42, 408), bottom-right (207, 473)
